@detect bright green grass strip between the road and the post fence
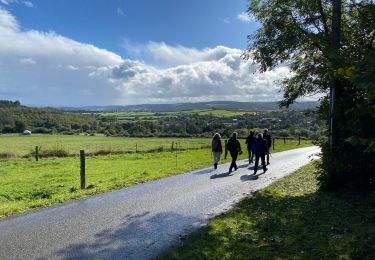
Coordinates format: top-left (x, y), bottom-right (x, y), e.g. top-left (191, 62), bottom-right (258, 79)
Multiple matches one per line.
top-left (0, 143), bottom-right (311, 218)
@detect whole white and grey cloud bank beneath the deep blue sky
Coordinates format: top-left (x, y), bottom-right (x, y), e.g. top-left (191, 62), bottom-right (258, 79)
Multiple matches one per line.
top-left (0, 7), bottom-right (289, 106)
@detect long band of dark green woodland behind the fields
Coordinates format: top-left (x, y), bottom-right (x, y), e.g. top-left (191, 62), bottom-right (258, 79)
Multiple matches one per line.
top-left (0, 101), bottom-right (323, 139)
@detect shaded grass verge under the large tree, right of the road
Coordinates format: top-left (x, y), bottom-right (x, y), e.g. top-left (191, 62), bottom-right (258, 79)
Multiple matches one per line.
top-left (161, 163), bottom-right (375, 259)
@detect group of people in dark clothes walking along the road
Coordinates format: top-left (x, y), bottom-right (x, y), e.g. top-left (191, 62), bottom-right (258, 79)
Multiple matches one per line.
top-left (212, 129), bottom-right (272, 175)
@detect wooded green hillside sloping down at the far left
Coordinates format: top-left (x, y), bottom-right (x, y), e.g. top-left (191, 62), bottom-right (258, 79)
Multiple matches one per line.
top-left (0, 100), bottom-right (97, 133)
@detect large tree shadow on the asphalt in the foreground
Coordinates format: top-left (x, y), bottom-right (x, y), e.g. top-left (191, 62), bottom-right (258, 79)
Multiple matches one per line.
top-left (56, 212), bottom-right (203, 260)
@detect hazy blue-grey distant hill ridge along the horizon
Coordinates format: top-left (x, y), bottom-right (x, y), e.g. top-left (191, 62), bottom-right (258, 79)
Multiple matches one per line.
top-left (59, 101), bottom-right (319, 112)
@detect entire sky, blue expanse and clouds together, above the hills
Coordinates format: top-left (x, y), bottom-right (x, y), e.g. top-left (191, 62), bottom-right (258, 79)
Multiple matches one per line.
top-left (0, 0), bottom-right (290, 107)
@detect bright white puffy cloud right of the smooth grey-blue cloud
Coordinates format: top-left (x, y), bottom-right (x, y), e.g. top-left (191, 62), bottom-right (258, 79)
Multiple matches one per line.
top-left (105, 43), bottom-right (289, 103)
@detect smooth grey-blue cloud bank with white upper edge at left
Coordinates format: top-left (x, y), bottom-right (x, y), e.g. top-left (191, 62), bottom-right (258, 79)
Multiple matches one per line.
top-left (0, 8), bottom-right (122, 105)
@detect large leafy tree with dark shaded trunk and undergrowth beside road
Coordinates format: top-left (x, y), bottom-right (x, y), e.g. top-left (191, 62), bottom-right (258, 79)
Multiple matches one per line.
top-left (244, 0), bottom-right (375, 189)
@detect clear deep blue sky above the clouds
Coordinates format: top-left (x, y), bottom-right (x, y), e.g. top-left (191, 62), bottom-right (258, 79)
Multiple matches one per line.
top-left (8, 0), bottom-right (256, 56)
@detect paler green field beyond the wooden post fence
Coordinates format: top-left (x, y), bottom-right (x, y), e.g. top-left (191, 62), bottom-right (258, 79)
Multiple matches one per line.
top-left (0, 134), bottom-right (210, 157)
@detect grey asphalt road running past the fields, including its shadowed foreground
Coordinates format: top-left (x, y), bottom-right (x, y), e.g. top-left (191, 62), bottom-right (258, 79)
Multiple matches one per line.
top-left (0, 147), bottom-right (319, 260)
